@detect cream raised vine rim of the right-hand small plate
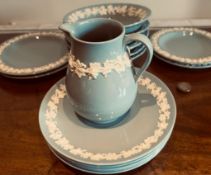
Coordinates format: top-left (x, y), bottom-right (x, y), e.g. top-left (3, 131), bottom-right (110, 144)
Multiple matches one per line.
top-left (151, 28), bottom-right (211, 65)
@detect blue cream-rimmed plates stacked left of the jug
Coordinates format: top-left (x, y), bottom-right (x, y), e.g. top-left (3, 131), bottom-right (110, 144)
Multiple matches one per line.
top-left (0, 31), bottom-right (68, 79)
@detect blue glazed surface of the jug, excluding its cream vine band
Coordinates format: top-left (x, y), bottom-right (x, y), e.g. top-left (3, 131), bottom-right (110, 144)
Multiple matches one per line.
top-left (60, 18), bottom-right (152, 124)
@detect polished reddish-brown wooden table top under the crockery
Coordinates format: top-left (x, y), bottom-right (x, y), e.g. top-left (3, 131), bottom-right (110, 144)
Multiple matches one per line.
top-left (0, 30), bottom-right (211, 175)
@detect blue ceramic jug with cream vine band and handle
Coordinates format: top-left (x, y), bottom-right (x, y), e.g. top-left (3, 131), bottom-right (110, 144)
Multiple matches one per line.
top-left (60, 18), bottom-right (153, 124)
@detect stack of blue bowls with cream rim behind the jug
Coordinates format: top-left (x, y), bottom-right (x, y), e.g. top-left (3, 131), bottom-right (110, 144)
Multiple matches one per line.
top-left (63, 3), bottom-right (151, 59)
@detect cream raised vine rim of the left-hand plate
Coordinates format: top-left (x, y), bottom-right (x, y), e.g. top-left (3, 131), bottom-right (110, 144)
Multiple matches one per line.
top-left (0, 32), bottom-right (68, 75)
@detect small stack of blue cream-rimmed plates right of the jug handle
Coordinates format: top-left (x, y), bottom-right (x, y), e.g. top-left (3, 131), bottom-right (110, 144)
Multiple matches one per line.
top-left (151, 28), bottom-right (211, 69)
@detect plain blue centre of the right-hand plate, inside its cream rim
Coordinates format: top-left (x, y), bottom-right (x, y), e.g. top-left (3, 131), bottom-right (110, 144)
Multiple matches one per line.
top-left (159, 31), bottom-right (211, 58)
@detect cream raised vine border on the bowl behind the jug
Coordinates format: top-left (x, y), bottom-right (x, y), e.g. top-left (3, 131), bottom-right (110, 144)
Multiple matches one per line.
top-left (65, 4), bottom-right (147, 23)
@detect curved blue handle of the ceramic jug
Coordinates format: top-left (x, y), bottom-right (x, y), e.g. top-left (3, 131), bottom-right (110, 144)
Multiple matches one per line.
top-left (125, 33), bottom-right (153, 81)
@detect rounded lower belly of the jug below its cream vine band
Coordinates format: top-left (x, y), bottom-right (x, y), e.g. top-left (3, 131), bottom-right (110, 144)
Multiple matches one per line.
top-left (66, 66), bottom-right (137, 123)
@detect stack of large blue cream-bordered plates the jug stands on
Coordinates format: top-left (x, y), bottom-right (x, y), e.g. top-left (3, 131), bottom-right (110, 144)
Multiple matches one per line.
top-left (39, 72), bottom-right (176, 174)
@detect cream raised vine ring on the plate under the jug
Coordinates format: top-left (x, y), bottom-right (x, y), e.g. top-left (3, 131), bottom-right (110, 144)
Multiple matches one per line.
top-left (45, 77), bottom-right (171, 161)
